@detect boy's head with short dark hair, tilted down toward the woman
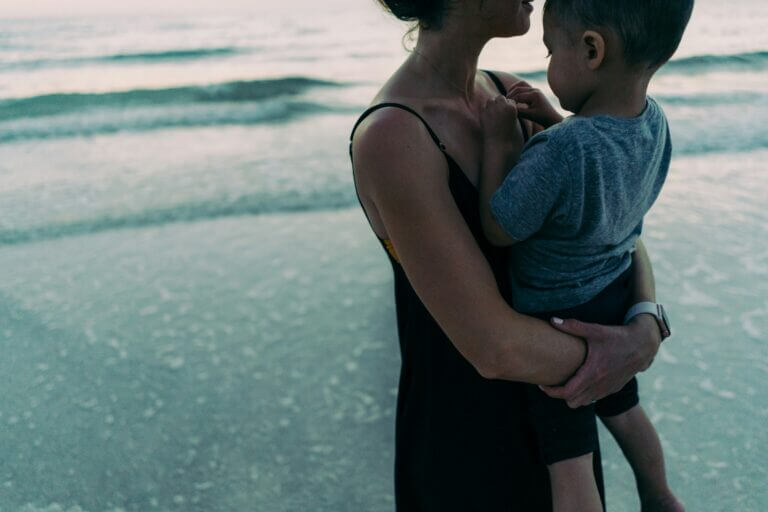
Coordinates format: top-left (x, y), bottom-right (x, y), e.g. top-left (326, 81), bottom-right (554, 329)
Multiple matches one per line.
top-left (544, 0), bottom-right (694, 111)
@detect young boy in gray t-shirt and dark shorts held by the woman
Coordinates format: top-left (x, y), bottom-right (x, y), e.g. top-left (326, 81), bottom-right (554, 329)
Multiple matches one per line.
top-left (479, 0), bottom-right (693, 512)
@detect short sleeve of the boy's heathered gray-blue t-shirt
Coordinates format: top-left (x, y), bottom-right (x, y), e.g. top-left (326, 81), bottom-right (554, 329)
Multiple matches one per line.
top-left (491, 134), bottom-right (568, 241)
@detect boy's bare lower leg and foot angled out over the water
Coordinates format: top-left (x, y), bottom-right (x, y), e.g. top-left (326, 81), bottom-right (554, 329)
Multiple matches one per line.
top-left (600, 405), bottom-right (685, 512)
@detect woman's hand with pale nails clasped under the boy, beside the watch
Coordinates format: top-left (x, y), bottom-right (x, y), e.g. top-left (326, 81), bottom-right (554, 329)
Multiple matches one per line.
top-left (541, 315), bottom-right (661, 409)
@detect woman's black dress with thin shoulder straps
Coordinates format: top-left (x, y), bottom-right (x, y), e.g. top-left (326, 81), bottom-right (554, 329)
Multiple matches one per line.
top-left (350, 72), bottom-right (603, 512)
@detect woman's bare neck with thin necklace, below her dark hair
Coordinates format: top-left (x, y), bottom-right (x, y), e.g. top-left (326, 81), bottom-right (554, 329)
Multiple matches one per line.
top-left (411, 27), bottom-right (488, 104)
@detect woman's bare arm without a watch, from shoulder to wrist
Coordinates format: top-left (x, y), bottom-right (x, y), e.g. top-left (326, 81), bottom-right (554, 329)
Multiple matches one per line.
top-left (353, 109), bottom-right (585, 384)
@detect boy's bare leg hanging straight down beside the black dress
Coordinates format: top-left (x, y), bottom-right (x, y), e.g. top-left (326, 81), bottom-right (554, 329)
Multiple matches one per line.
top-left (547, 453), bottom-right (603, 512)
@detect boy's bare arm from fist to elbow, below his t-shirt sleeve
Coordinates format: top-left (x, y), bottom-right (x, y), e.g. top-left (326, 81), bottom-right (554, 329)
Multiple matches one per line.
top-left (478, 96), bottom-right (524, 247)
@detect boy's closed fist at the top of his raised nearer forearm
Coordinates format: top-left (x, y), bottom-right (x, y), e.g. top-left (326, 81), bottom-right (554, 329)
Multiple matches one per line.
top-left (480, 96), bottom-right (525, 167)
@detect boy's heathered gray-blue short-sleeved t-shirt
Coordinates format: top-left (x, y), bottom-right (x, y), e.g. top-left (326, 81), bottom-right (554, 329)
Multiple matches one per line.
top-left (491, 98), bottom-right (672, 313)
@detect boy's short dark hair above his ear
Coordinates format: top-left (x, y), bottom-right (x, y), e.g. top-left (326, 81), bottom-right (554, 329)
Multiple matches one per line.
top-left (544, 0), bottom-right (694, 69)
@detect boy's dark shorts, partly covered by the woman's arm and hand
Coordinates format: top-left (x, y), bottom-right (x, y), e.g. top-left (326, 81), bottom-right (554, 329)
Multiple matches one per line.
top-left (526, 265), bottom-right (639, 465)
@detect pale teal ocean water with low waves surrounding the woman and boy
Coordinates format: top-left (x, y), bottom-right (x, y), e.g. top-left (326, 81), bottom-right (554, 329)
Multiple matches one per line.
top-left (0, 0), bottom-right (768, 512)
